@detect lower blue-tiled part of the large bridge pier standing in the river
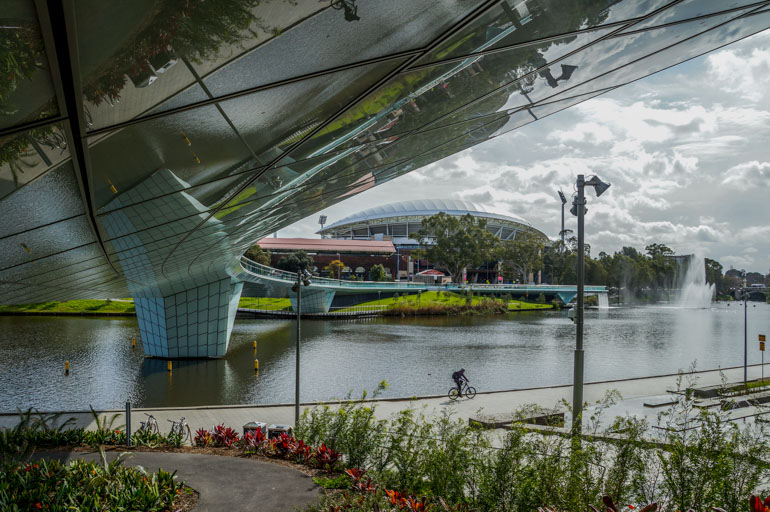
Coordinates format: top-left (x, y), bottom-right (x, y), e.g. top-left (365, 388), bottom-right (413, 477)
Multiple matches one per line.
top-left (134, 278), bottom-right (243, 359)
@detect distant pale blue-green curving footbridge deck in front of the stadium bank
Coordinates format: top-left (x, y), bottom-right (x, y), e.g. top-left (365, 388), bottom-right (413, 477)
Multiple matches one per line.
top-left (237, 256), bottom-right (608, 313)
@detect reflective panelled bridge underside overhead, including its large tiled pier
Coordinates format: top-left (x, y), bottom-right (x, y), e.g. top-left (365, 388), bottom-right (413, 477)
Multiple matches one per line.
top-left (0, 0), bottom-right (770, 357)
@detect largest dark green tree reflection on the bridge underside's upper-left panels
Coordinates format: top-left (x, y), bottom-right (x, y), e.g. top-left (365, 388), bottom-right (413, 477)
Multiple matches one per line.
top-left (83, 0), bottom-right (267, 105)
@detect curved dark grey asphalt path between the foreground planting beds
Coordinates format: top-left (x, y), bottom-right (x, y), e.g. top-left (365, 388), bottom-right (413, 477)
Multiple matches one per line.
top-left (42, 451), bottom-right (321, 512)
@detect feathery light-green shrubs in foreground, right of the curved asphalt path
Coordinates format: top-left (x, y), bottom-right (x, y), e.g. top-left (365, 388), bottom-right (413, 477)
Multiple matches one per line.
top-left (297, 380), bottom-right (770, 512)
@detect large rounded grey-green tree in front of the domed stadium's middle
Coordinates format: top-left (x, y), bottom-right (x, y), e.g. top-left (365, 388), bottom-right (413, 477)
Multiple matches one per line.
top-left (416, 212), bottom-right (498, 282)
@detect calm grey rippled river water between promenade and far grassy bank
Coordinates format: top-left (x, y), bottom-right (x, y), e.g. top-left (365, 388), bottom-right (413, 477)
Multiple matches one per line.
top-left (0, 303), bottom-right (770, 412)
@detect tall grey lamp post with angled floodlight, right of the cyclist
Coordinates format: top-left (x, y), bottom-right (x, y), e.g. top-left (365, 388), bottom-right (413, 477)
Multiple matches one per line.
top-left (570, 174), bottom-right (610, 435)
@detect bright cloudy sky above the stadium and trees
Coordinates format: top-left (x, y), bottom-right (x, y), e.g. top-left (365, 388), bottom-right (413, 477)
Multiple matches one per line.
top-left (278, 30), bottom-right (770, 273)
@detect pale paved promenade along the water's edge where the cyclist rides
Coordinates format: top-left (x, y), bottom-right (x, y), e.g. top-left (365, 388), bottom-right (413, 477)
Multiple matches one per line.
top-left (0, 363), bottom-right (770, 434)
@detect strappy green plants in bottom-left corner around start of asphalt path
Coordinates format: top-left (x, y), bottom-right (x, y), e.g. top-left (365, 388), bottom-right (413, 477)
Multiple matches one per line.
top-left (0, 410), bottom-right (186, 512)
